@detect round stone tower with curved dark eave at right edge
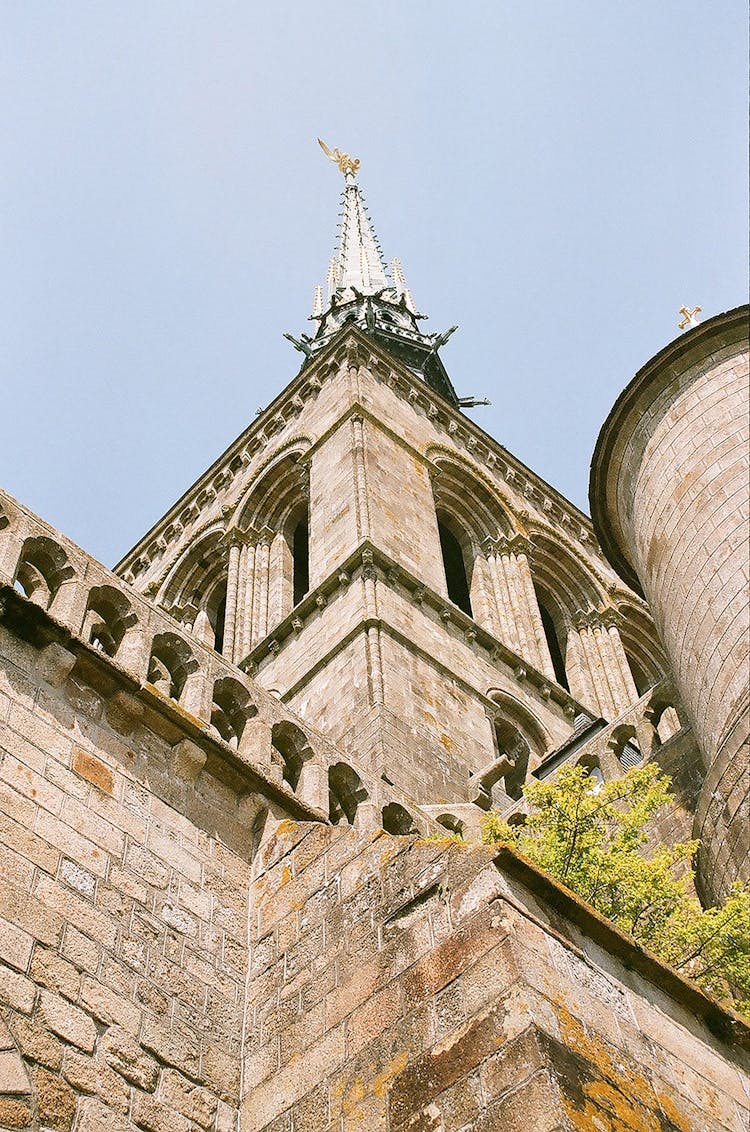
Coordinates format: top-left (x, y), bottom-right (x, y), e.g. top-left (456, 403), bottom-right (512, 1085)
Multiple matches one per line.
top-left (589, 307), bottom-right (750, 901)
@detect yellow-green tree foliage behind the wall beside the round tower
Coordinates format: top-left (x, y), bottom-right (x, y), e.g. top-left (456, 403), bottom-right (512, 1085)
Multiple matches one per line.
top-left (483, 764), bottom-right (750, 1013)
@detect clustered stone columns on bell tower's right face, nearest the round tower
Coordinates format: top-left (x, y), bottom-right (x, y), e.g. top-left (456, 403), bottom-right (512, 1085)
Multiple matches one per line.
top-left (566, 609), bottom-right (638, 720)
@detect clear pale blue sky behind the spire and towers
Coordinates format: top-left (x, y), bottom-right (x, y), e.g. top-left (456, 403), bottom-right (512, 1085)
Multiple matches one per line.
top-left (0, 0), bottom-right (747, 565)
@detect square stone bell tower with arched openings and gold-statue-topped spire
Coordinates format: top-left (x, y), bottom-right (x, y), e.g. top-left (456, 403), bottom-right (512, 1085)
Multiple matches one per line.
top-left (117, 151), bottom-right (664, 821)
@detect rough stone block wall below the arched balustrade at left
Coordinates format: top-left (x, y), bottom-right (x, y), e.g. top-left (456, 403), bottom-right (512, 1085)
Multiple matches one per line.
top-left (0, 629), bottom-right (250, 1132)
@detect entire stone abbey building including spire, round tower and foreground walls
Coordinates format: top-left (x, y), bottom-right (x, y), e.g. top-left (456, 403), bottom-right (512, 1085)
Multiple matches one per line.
top-left (0, 147), bottom-right (750, 1132)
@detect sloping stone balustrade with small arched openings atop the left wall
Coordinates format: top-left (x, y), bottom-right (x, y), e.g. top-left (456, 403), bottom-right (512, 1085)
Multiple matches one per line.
top-left (0, 494), bottom-right (432, 832)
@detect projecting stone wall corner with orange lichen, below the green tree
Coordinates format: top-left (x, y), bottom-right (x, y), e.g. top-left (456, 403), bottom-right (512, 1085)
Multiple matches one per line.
top-left (241, 822), bottom-right (750, 1132)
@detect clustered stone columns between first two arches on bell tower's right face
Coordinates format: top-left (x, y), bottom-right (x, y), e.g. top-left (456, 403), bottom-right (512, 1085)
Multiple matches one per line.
top-left (486, 534), bottom-right (555, 680)
